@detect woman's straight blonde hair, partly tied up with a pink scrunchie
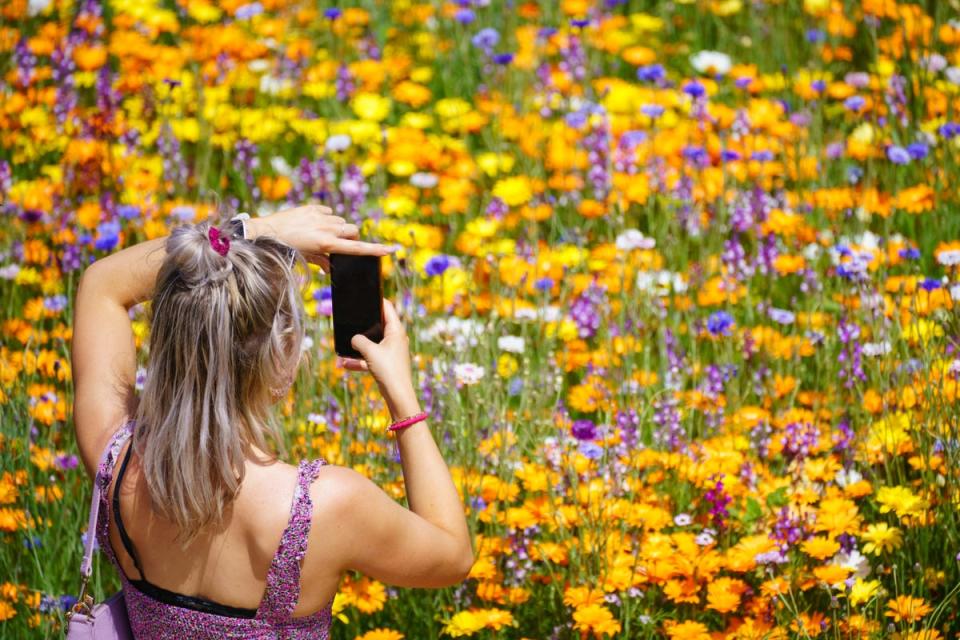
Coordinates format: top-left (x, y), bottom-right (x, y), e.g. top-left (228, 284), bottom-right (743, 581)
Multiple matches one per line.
top-left (134, 222), bottom-right (306, 544)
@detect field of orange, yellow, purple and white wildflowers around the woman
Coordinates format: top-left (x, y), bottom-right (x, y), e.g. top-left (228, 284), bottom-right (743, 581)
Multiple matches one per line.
top-left (0, 0), bottom-right (960, 640)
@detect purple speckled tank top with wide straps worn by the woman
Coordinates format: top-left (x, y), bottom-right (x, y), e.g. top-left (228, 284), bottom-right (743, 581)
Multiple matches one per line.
top-left (96, 421), bottom-right (333, 640)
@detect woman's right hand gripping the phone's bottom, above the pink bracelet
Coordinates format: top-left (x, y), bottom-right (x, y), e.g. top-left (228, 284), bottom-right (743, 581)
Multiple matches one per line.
top-left (340, 299), bottom-right (420, 419)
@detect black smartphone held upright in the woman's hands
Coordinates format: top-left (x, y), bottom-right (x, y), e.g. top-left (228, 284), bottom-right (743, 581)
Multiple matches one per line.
top-left (330, 253), bottom-right (383, 359)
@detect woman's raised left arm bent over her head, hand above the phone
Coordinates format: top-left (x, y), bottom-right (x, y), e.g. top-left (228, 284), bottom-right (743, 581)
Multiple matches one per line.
top-left (71, 205), bottom-right (390, 476)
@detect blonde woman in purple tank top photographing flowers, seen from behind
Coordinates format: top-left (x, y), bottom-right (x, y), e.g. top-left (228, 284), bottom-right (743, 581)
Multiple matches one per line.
top-left (73, 206), bottom-right (473, 640)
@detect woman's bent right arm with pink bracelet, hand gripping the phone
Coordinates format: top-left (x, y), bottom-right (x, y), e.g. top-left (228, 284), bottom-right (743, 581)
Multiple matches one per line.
top-left (314, 300), bottom-right (474, 587)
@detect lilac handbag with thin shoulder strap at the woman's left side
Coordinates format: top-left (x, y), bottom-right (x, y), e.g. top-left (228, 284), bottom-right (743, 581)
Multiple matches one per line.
top-left (67, 438), bottom-right (133, 640)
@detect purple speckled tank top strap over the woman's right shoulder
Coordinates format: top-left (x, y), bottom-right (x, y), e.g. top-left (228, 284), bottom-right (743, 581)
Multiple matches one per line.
top-left (257, 458), bottom-right (326, 622)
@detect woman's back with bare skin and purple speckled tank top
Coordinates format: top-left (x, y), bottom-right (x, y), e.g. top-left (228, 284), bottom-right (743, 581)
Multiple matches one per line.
top-left (97, 422), bottom-right (339, 638)
